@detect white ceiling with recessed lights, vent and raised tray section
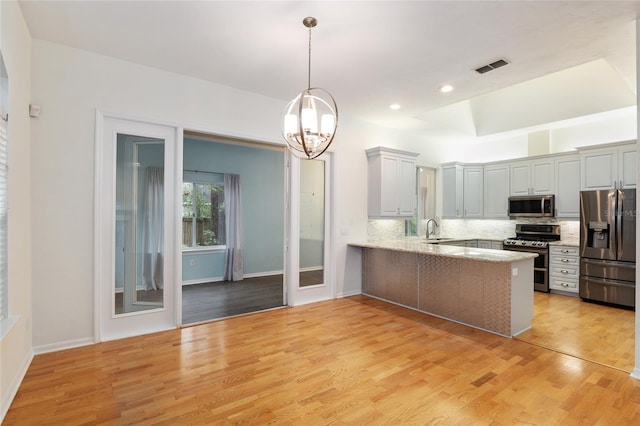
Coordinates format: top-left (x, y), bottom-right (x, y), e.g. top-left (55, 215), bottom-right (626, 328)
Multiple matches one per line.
top-left (20, 0), bottom-right (640, 137)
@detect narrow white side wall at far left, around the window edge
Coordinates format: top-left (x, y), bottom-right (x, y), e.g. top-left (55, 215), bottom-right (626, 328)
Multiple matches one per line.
top-left (0, 1), bottom-right (33, 421)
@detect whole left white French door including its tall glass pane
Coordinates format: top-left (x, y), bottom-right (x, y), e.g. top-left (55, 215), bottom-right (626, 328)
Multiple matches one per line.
top-left (94, 113), bottom-right (182, 341)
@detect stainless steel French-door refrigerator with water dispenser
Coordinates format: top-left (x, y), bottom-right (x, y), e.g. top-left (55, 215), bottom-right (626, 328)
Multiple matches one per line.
top-left (579, 189), bottom-right (636, 307)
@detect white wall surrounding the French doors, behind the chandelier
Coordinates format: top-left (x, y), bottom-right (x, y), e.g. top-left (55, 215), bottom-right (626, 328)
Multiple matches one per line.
top-left (32, 40), bottom-right (438, 351)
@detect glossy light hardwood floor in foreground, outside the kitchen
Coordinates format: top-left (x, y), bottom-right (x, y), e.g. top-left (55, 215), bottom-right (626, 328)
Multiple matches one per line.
top-left (3, 296), bottom-right (640, 426)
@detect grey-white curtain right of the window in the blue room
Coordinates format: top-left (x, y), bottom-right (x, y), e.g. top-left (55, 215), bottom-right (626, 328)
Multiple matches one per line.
top-left (224, 174), bottom-right (244, 281)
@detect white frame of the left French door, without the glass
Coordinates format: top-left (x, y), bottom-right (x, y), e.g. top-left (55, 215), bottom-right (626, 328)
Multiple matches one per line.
top-left (93, 109), bottom-right (183, 342)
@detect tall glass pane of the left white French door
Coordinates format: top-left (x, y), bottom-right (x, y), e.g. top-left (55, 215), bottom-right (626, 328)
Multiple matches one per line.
top-left (113, 134), bottom-right (164, 315)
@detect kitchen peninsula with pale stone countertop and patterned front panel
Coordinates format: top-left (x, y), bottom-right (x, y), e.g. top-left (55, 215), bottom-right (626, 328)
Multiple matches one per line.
top-left (349, 238), bottom-right (536, 337)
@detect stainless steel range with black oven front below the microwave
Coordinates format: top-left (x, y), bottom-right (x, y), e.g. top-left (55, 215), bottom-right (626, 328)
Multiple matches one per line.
top-left (502, 223), bottom-right (560, 293)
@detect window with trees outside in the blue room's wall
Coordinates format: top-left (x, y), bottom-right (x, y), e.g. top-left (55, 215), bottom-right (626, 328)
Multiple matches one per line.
top-left (182, 172), bottom-right (225, 248)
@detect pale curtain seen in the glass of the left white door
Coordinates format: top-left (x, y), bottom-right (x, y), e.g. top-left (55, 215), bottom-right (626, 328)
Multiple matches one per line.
top-left (142, 167), bottom-right (164, 290)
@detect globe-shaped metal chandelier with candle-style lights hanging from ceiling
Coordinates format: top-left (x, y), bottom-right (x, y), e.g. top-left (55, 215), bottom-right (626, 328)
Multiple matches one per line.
top-left (282, 17), bottom-right (338, 160)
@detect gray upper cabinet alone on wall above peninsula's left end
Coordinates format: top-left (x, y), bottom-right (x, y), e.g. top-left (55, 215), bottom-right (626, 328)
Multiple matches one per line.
top-left (366, 147), bottom-right (418, 218)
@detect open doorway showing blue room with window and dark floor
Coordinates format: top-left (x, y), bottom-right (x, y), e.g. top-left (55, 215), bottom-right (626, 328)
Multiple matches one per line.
top-left (181, 132), bottom-right (287, 325)
